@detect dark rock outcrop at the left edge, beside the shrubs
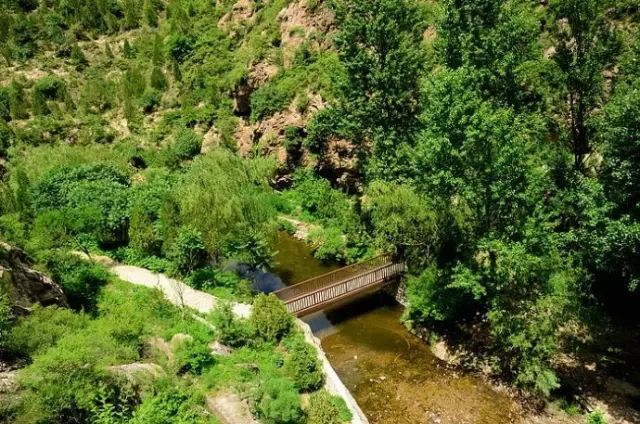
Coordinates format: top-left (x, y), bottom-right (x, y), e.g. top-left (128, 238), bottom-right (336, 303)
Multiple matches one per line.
top-left (0, 241), bottom-right (68, 314)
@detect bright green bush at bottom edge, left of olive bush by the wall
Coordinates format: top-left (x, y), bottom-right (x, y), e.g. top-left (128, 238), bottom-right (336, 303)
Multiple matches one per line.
top-left (256, 378), bottom-right (304, 424)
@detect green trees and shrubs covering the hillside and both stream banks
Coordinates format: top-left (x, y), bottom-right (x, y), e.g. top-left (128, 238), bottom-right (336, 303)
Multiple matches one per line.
top-left (0, 0), bottom-right (640, 423)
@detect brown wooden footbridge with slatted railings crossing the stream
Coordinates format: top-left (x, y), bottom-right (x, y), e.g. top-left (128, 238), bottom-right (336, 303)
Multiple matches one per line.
top-left (275, 255), bottom-right (406, 317)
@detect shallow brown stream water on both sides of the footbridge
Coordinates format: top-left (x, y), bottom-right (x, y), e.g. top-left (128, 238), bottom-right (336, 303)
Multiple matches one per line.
top-left (274, 234), bottom-right (519, 424)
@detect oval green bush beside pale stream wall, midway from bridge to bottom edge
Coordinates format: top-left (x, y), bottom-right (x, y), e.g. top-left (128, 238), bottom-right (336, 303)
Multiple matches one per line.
top-left (284, 334), bottom-right (324, 392)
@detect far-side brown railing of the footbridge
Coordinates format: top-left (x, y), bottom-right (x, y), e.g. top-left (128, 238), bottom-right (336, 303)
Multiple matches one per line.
top-left (275, 254), bottom-right (394, 302)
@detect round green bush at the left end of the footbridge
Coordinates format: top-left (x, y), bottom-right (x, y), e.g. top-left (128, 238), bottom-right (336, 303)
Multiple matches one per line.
top-left (249, 294), bottom-right (293, 341)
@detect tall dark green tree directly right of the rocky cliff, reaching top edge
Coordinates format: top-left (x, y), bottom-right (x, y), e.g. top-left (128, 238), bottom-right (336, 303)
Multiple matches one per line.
top-left (317, 0), bottom-right (426, 176)
